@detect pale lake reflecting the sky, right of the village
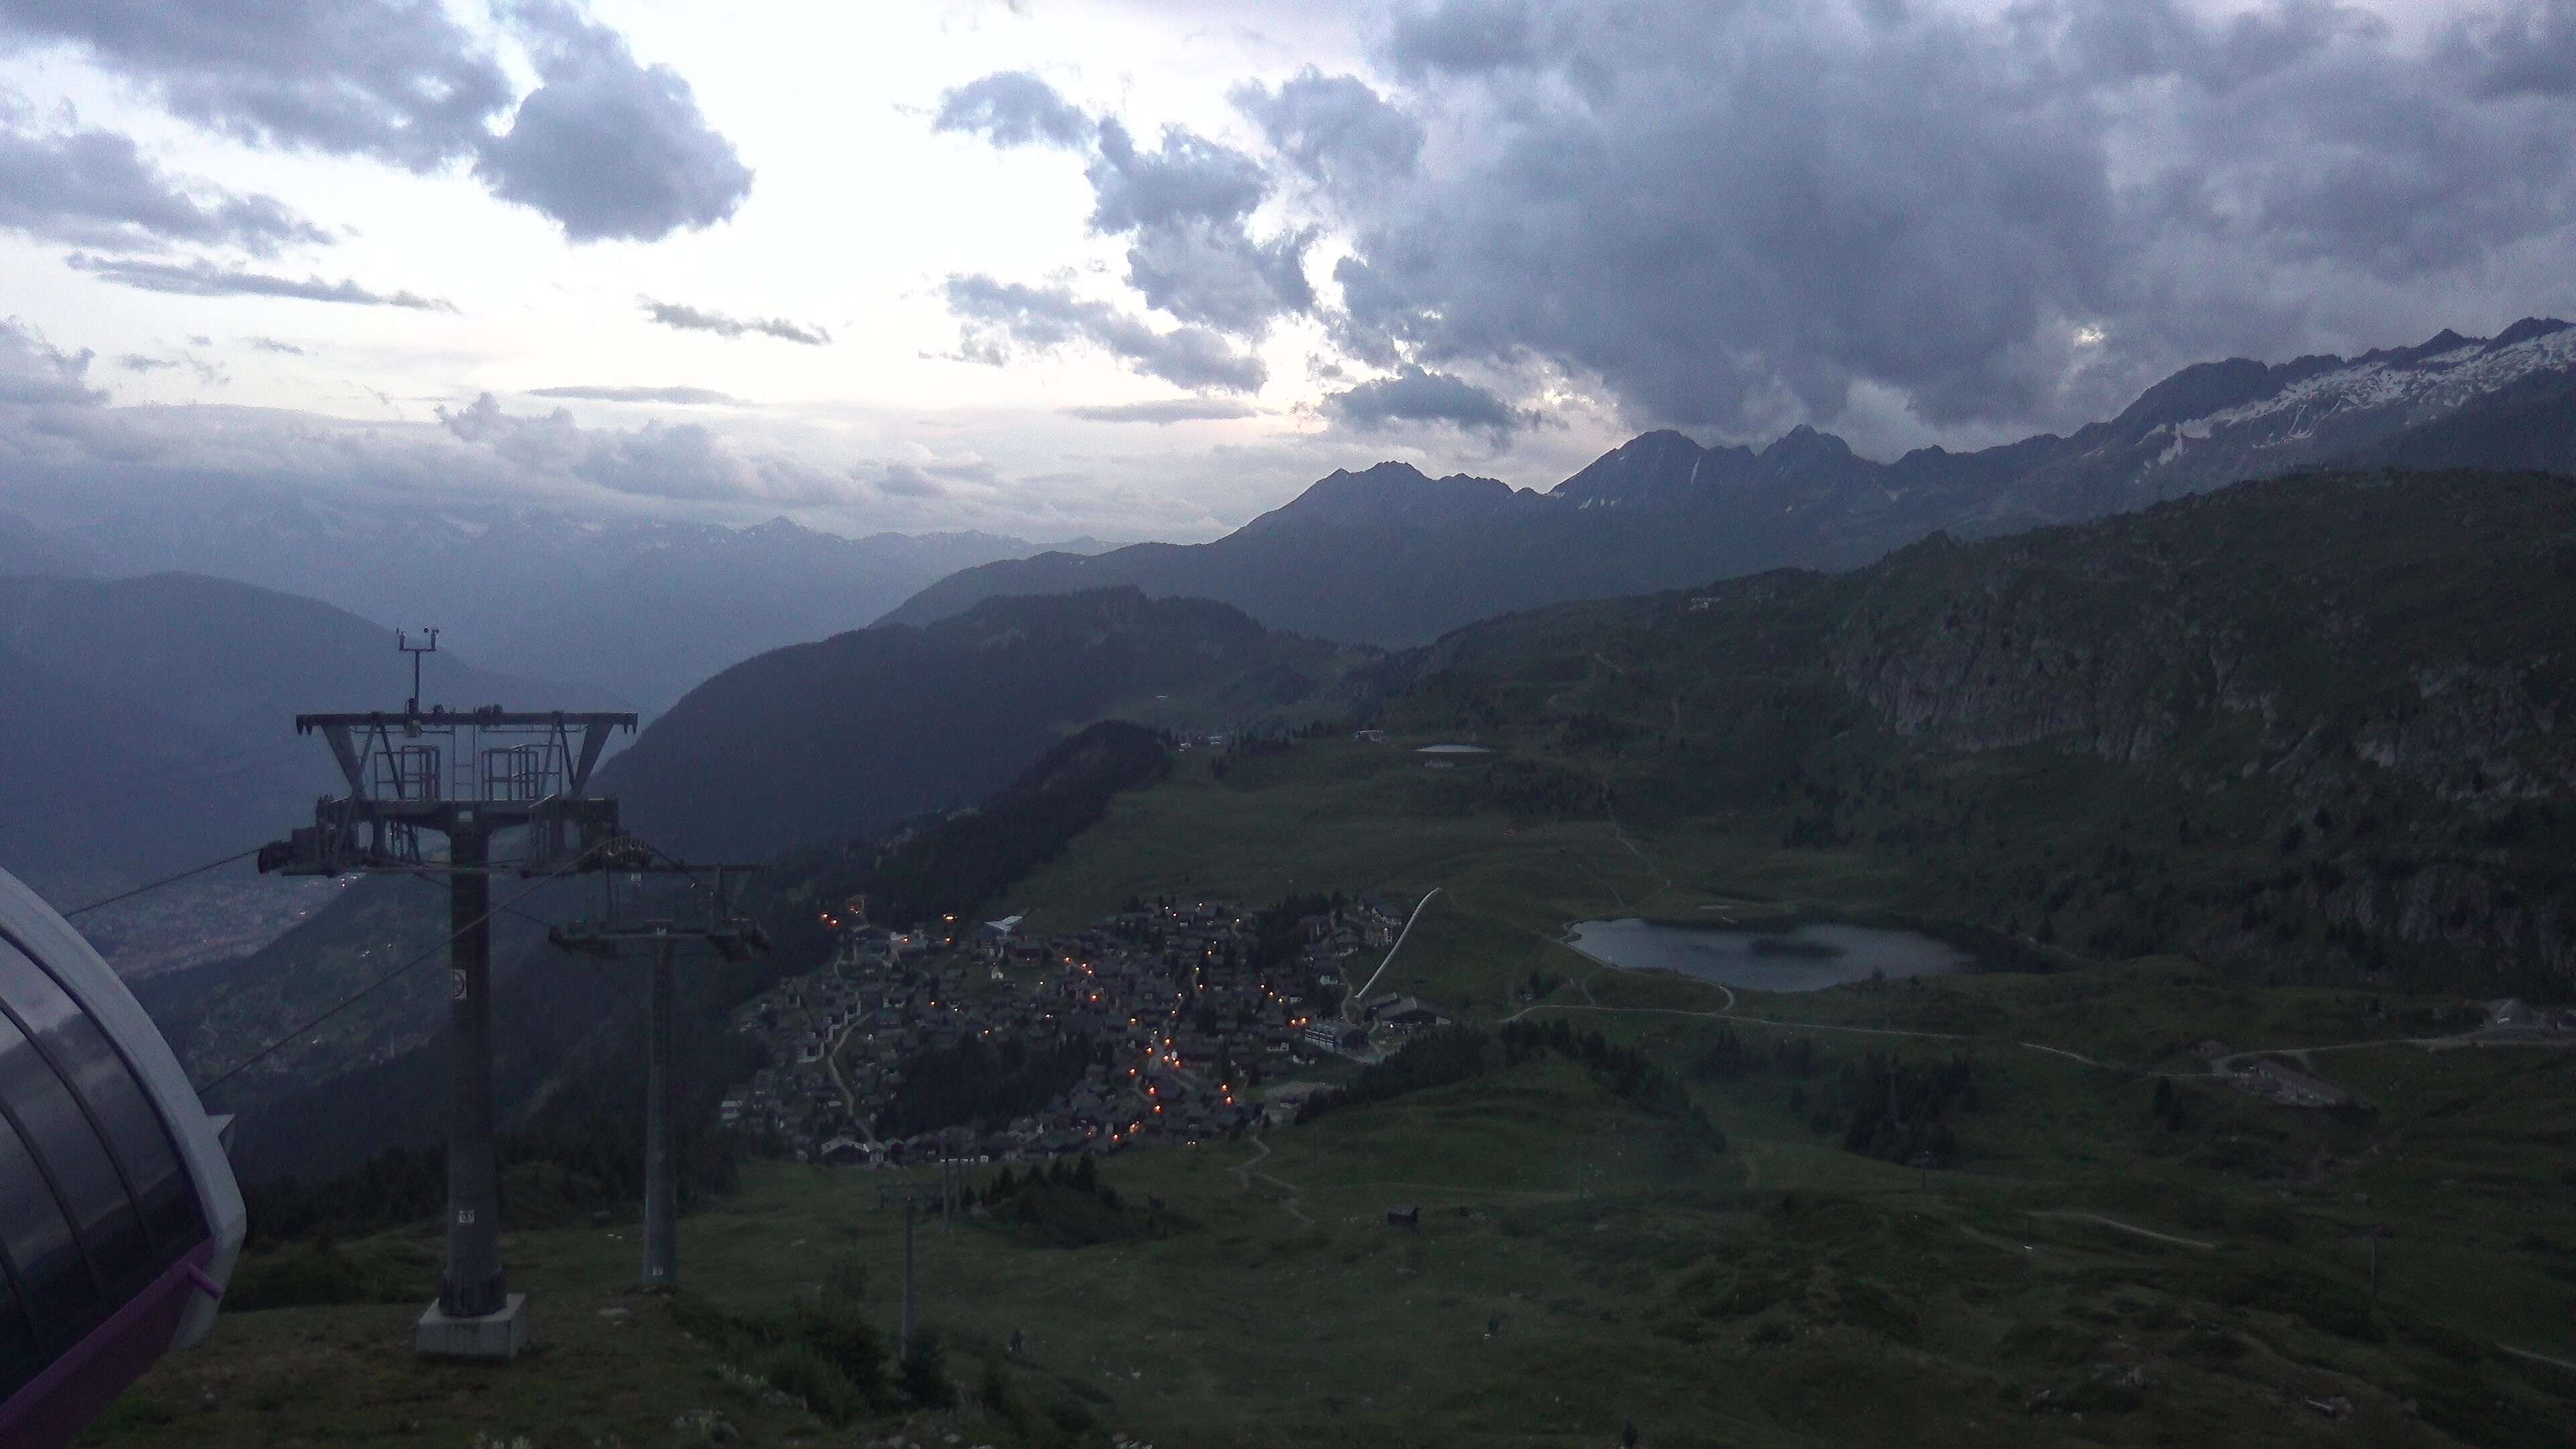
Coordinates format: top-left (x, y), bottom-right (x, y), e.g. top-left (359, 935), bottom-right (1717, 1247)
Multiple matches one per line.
top-left (1569, 918), bottom-right (1976, 990)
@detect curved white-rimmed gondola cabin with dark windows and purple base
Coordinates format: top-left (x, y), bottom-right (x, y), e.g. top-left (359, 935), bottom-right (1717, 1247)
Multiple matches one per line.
top-left (0, 871), bottom-right (242, 1449)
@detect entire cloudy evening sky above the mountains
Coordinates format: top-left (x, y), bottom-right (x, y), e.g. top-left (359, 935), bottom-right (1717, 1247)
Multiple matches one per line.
top-left (0, 0), bottom-right (2576, 539)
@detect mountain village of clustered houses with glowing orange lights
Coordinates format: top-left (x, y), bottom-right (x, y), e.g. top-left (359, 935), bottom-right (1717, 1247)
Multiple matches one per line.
top-left (718, 900), bottom-right (1445, 1168)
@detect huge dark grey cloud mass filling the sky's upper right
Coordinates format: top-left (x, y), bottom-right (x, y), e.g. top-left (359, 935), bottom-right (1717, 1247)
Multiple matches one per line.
top-left (1308, 0), bottom-right (2576, 433)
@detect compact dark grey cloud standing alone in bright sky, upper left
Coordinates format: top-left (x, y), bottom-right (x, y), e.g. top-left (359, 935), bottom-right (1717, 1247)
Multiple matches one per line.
top-left (474, 3), bottom-right (752, 242)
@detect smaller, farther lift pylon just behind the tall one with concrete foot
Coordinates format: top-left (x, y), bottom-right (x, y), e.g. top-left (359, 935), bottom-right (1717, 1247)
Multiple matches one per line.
top-left (546, 835), bottom-right (770, 1292)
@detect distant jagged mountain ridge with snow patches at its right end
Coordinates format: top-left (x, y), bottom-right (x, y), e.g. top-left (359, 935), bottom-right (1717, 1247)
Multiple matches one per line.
top-left (886, 317), bottom-right (2576, 647)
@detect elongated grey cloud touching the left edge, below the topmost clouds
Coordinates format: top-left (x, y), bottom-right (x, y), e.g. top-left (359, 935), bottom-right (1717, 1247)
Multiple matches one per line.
top-left (0, 116), bottom-right (330, 255)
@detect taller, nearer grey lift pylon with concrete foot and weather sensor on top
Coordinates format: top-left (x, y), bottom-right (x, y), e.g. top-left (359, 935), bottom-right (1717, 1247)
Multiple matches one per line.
top-left (260, 632), bottom-right (636, 1358)
